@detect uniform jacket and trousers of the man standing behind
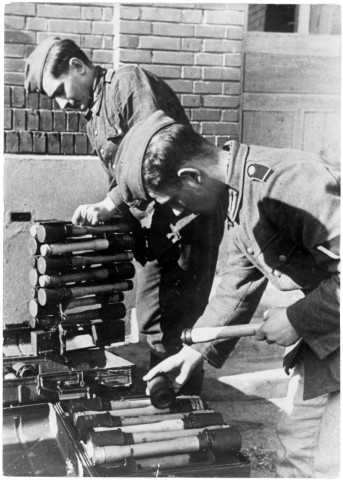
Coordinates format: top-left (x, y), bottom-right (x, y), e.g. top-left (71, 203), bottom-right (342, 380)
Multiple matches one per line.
top-left (86, 66), bottom-right (226, 364)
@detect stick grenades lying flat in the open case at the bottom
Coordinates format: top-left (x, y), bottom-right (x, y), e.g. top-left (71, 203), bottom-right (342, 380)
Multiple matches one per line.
top-left (68, 396), bottom-right (241, 476)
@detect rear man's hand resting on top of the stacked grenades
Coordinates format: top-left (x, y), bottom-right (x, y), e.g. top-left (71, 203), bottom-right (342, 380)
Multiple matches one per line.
top-left (71, 197), bottom-right (116, 225)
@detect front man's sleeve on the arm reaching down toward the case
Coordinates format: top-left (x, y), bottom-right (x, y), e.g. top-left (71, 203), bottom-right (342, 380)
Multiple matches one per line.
top-left (192, 230), bottom-right (268, 368)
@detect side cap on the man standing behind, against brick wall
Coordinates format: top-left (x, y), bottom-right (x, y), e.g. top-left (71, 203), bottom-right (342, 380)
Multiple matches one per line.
top-left (25, 37), bottom-right (61, 93)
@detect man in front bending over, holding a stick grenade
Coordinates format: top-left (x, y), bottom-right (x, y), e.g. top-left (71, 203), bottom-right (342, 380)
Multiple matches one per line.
top-left (117, 111), bottom-right (340, 478)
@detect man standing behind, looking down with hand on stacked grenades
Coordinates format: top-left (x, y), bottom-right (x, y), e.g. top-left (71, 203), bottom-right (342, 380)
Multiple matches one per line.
top-left (25, 38), bottom-right (225, 394)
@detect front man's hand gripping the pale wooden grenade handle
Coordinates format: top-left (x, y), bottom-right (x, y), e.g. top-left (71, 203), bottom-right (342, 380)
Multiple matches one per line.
top-left (256, 307), bottom-right (300, 347)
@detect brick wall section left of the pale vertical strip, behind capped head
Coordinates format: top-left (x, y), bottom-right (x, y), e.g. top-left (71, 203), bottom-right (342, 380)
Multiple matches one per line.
top-left (4, 2), bottom-right (116, 155)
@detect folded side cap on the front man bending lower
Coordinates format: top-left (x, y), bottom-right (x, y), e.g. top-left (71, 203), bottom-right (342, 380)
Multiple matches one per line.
top-left (115, 110), bottom-right (176, 207)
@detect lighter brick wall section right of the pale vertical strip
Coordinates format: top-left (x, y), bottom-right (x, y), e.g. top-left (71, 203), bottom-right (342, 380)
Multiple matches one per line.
top-left (118, 3), bottom-right (247, 145)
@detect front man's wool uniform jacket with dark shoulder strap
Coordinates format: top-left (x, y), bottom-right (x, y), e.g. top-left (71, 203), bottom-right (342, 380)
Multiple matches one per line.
top-left (193, 142), bottom-right (340, 399)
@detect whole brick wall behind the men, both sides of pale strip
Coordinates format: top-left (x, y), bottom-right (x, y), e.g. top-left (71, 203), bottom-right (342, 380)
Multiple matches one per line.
top-left (4, 2), bottom-right (247, 155)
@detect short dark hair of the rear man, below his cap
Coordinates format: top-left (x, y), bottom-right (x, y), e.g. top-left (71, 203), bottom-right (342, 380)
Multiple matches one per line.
top-left (44, 39), bottom-right (92, 78)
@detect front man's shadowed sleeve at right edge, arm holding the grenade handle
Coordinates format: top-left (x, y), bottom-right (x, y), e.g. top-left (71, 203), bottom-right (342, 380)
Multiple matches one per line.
top-left (263, 162), bottom-right (340, 359)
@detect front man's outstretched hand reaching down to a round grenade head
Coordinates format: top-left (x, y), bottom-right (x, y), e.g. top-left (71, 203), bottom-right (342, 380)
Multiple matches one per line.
top-left (143, 345), bottom-right (203, 391)
